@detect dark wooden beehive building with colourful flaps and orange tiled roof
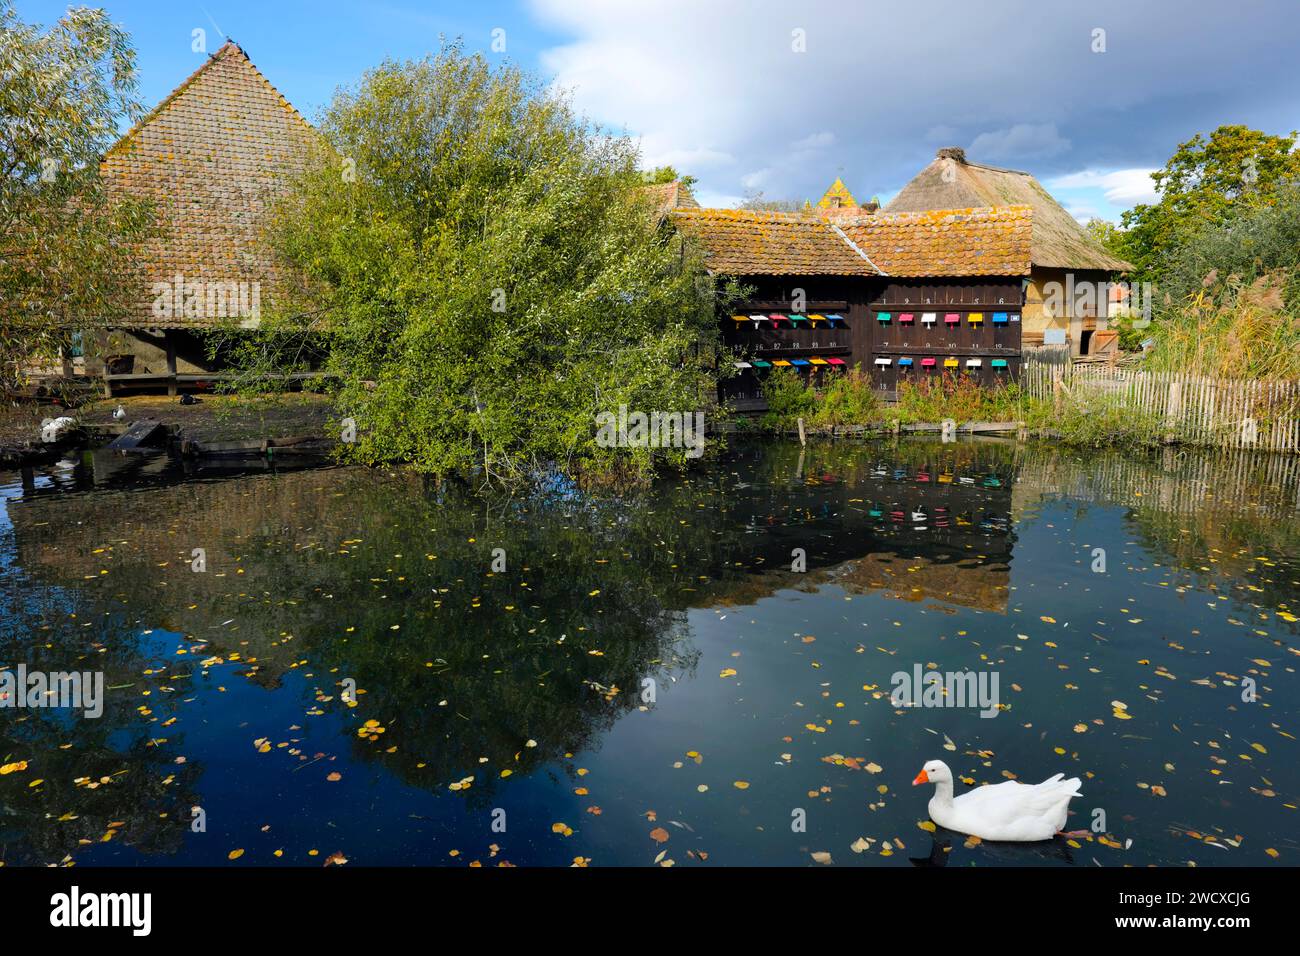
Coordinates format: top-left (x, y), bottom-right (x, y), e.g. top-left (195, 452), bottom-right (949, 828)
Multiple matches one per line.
top-left (671, 206), bottom-right (1032, 411)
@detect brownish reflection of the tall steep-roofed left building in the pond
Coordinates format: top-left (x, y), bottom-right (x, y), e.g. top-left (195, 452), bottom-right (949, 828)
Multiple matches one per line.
top-left (8, 454), bottom-right (384, 684)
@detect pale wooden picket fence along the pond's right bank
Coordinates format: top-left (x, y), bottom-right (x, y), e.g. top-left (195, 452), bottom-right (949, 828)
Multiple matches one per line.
top-left (1021, 349), bottom-right (1300, 453)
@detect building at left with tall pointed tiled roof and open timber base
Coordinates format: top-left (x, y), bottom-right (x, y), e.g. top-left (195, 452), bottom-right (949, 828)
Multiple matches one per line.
top-left (87, 42), bottom-right (316, 392)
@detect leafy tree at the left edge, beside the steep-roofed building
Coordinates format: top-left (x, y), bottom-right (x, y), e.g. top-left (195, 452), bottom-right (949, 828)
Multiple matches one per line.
top-left (0, 0), bottom-right (152, 392)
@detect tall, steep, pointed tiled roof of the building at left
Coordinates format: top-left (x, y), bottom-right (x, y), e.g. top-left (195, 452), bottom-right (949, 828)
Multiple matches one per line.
top-left (100, 42), bottom-right (316, 328)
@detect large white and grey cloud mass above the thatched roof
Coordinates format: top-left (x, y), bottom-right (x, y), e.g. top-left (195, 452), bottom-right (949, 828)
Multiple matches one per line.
top-left (527, 0), bottom-right (1300, 208)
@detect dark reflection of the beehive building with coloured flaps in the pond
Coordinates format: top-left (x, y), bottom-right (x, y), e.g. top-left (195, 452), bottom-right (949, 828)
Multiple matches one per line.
top-left (696, 442), bottom-right (1014, 611)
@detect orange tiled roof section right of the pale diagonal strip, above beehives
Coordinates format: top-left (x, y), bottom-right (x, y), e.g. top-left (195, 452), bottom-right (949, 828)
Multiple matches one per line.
top-left (837, 206), bottom-right (1034, 277)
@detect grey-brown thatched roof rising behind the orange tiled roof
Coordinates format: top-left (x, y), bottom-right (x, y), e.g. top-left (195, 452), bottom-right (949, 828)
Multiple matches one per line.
top-left (885, 147), bottom-right (1134, 272)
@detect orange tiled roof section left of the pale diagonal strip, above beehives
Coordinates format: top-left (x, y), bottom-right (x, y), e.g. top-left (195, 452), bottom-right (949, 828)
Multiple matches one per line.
top-left (671, 209), bottom-right (879, 276)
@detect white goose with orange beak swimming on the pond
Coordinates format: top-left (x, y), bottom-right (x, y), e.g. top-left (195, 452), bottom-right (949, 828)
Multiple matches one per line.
top-left (911, 760), bottom-right (1080, 843)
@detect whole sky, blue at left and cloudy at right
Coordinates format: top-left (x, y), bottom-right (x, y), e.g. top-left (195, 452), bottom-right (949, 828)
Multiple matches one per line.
top-left (17, 0), bottom-right (1300, 220)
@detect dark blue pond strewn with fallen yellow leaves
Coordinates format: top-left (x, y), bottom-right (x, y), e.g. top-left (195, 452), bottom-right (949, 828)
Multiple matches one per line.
top-left (0, 440), bottom-right (1300, 866)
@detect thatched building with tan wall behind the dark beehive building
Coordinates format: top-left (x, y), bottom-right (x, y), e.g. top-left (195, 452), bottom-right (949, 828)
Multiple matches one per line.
top-left (884, 147), bottom-right (1132, 355)
